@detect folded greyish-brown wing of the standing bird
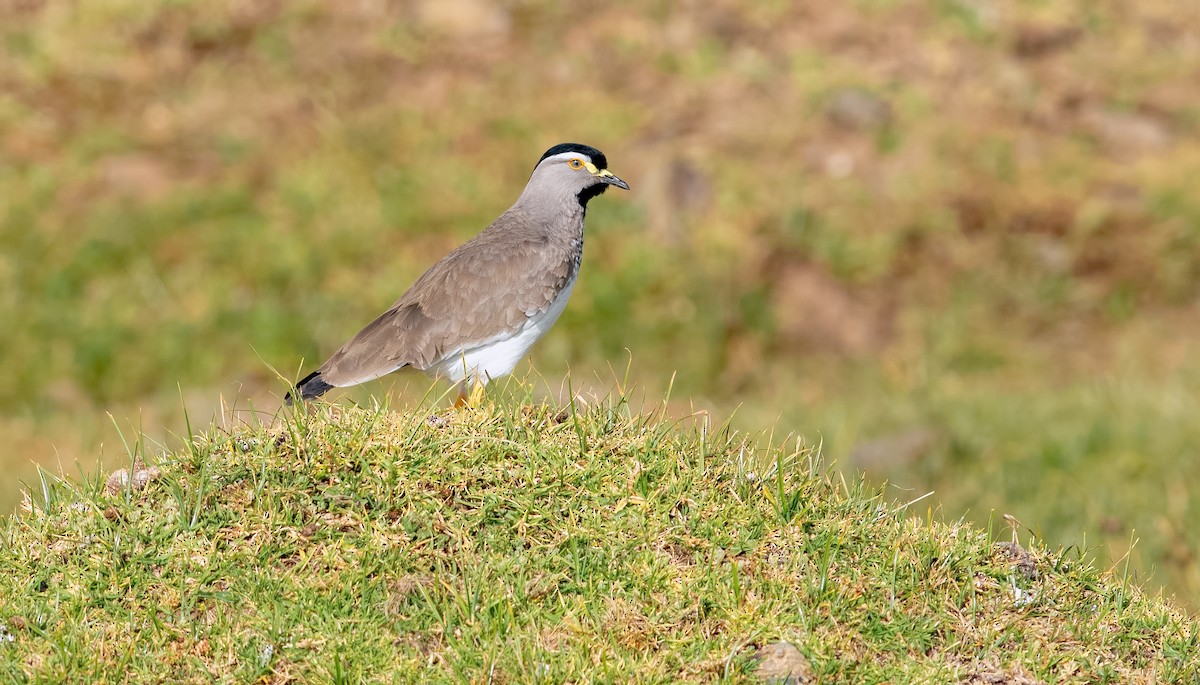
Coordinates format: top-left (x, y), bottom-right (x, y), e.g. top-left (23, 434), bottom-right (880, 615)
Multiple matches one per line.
top-left (317, 217), bottom-right (574, 387)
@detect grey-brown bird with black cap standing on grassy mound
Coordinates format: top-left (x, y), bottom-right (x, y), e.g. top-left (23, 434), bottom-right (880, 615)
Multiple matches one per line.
top-left (284, 143), bottom-right (629, 405)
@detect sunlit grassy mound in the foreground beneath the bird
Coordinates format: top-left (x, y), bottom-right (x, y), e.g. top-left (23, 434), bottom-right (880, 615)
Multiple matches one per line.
top-left (0, 403), bottom-right (1200, 683)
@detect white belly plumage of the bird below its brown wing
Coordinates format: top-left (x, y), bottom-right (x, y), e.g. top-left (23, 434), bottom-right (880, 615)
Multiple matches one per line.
top-left (426, 280), bottom-right (575, 384)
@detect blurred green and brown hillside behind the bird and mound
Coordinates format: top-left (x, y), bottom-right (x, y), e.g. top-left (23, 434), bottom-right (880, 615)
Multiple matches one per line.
top-left (0, 0), bottom-right (1200, 611)
